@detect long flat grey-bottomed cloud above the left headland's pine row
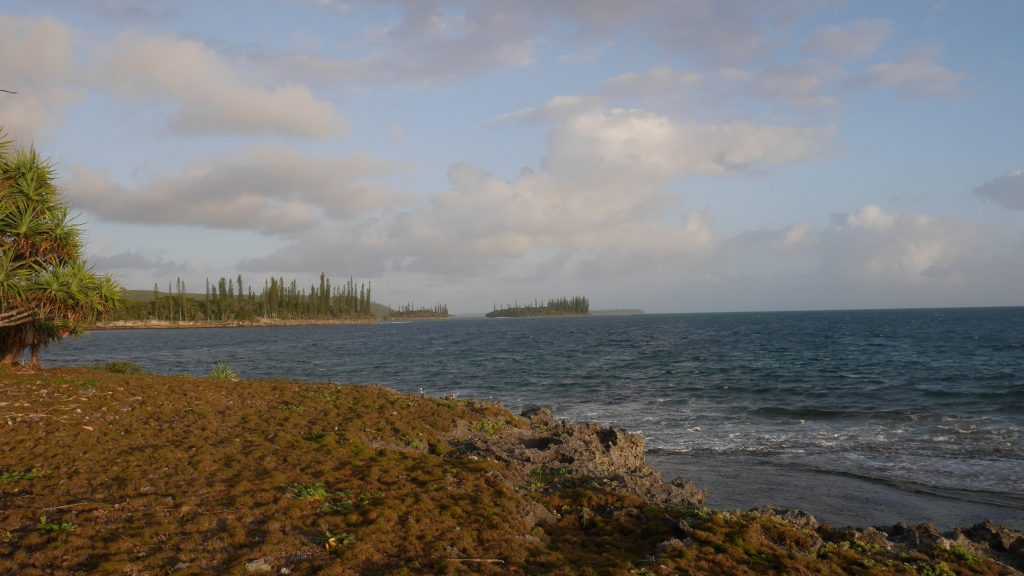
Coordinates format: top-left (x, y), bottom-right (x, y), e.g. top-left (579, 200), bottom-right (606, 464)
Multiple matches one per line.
top-left (66, 147), bottom-right (401, 234)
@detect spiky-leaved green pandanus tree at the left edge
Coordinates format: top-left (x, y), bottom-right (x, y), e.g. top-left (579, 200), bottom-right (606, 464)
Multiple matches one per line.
top-left (0, 135), bottom-right (121, 366)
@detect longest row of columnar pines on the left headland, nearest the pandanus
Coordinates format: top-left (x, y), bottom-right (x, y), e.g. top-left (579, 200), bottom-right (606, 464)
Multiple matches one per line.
top-left (104, 274), bottom-right (374, 321)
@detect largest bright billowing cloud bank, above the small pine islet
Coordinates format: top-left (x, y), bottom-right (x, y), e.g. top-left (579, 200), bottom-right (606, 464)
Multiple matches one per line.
top-left (244, 110), bottom-right (833, 277)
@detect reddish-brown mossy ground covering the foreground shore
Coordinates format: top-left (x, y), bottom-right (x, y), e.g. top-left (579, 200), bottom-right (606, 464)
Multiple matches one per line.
top-left (0, 369), bottom-right (1006, 575)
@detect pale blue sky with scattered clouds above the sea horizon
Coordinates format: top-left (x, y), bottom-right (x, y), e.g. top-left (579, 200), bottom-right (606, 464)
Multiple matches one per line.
top-left (0, 0), bottom-right (1024, 314)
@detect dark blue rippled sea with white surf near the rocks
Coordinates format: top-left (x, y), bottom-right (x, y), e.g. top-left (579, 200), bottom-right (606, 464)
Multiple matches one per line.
top-left (42, 307), bottom-right (1024, 529)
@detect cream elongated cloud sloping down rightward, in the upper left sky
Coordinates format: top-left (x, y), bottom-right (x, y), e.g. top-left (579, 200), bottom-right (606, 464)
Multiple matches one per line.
top-left (104, 33), bottom-right (345, 138)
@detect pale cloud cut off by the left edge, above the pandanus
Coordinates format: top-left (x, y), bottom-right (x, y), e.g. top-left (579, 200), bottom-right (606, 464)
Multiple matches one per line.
top-left (0, 13), bottom-right (80, 143)
